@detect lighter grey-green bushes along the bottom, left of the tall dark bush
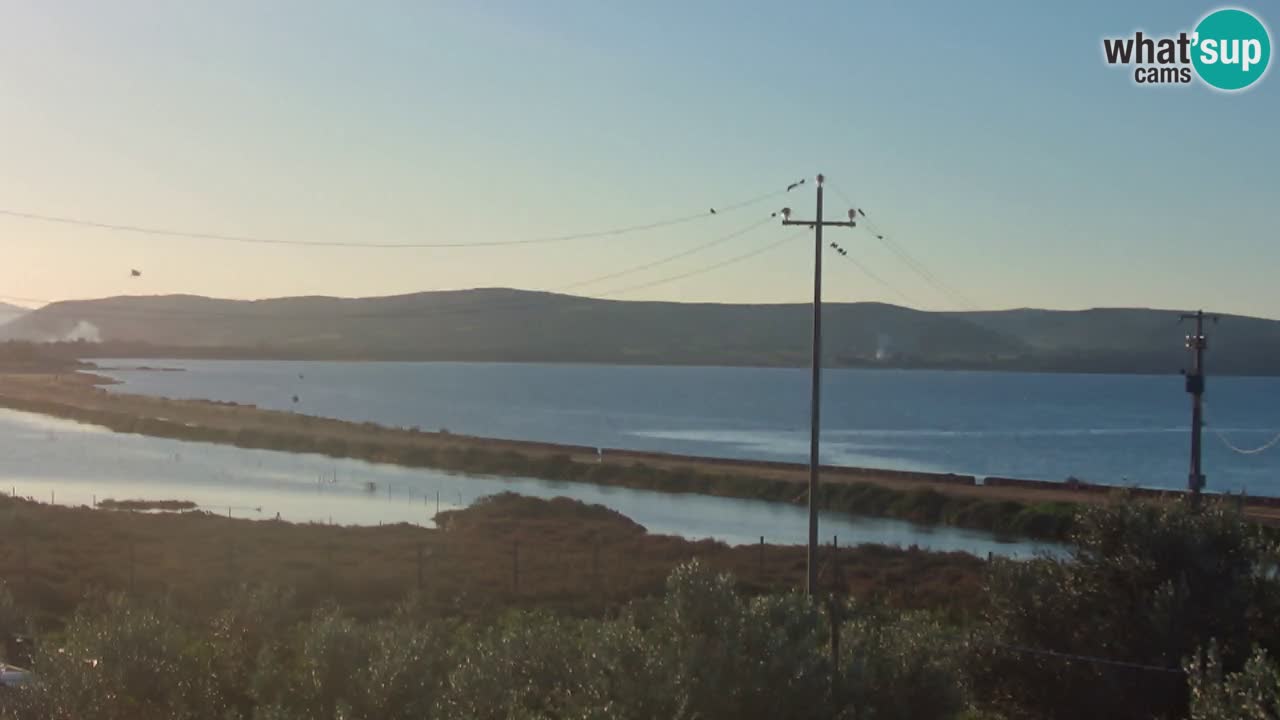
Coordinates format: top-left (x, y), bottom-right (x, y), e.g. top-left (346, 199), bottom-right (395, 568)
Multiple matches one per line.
top-left (0, 562), bottom-right (966, 720)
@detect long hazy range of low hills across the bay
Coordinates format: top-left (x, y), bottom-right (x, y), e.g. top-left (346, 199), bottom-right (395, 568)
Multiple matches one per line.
top-left (0, 290), bottom-right (1280, 374)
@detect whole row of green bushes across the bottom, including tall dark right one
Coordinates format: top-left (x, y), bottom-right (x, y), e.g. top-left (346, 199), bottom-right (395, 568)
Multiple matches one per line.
top-left (0, 502), bottom-right (1280, 720)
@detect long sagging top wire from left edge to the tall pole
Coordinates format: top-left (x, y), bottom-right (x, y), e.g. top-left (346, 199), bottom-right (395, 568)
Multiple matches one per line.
top-left (0, 181), bottom-right (786, 250)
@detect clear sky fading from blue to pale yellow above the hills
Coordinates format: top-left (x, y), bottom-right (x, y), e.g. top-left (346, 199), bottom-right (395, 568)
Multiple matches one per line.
top-left (0, 0), bottom-right (1280, 318)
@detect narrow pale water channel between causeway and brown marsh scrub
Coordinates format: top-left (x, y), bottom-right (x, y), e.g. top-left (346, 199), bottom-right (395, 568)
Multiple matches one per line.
top-left (0, 410), bottom-right (1056, 557)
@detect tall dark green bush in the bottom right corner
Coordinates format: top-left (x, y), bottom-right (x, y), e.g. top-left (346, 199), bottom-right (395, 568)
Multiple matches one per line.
top-left (975, 502), bottom-right (1280, 717)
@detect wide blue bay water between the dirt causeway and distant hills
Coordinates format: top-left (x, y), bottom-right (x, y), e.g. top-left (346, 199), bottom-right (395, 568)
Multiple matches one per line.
top-left (100, 360), bottom-right (1280, 495)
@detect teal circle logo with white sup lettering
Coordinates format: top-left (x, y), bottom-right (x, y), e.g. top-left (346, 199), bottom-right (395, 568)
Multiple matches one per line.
top-left (1192, 8), bottom-right (1271, 91)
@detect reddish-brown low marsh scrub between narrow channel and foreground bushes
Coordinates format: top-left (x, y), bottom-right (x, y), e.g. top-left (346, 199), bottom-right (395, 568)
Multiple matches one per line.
top-left (0, 495), bottom-right (984, 626)
